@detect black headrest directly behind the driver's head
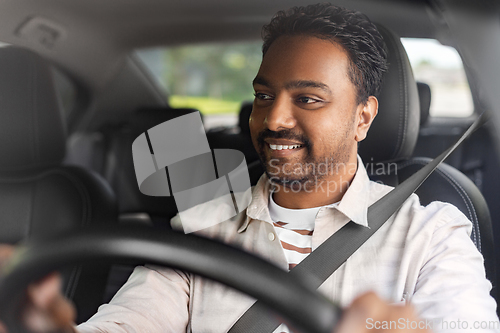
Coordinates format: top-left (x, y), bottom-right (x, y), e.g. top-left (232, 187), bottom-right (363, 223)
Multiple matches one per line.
top-left (358, 25), bottom-right (420, 163)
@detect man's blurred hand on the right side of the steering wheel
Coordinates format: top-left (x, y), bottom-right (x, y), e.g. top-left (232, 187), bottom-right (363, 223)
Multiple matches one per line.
top-left (336, 292), bottom-right (431, 333)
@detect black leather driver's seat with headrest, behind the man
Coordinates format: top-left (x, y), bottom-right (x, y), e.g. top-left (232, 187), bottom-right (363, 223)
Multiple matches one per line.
top-left (359, 27), bottom-right (496, 284)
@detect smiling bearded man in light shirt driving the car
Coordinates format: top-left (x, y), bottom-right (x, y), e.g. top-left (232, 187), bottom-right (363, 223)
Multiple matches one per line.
top-left (0, 4), bottom-right (498, 332)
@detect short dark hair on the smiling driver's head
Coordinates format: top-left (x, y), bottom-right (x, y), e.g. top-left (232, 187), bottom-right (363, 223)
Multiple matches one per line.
top-left (262, 3), bottom-right (387, 104)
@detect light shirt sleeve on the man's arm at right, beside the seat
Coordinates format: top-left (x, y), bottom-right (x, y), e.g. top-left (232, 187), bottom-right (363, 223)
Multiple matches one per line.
top-left (411, 205), bottom-right (500, 333)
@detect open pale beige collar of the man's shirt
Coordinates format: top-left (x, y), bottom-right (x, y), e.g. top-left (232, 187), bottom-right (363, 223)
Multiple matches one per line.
top-left (238, 155), bottom-right (370, 233)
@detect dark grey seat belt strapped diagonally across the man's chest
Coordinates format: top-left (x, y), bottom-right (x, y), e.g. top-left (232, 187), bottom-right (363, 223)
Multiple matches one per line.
top-left (228, 112), bottom-right (484, 333)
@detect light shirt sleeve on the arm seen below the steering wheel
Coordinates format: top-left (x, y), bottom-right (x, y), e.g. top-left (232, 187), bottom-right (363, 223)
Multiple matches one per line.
top-left (76, 266), bottom-right (190, 333)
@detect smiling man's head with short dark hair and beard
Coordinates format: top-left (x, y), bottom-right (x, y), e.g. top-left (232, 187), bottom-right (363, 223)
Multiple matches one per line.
top-left (250, 4), bottom-right (386, 200)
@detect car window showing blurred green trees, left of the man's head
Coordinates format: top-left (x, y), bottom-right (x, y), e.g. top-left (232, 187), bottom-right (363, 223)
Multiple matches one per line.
top-left (136, 41), bottom-right (262, 129)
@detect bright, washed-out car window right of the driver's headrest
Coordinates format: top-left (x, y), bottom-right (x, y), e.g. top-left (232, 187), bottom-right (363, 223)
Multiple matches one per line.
top-left (401, 38), bottom-right (474, 117)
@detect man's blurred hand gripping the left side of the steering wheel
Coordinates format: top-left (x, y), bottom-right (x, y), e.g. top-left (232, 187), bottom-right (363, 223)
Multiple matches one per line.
top-left (0, 244), bottom-right (76, 333)
